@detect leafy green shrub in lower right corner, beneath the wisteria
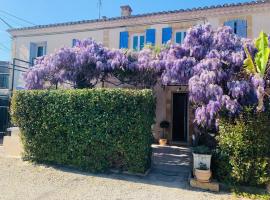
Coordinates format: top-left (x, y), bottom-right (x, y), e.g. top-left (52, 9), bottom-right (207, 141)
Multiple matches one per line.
top-left (214, 110), bottom-right (270, 186)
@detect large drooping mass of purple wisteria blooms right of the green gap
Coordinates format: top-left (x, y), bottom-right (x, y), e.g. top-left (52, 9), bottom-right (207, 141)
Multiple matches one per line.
top-left (159, 24), bottom-right (257, 127)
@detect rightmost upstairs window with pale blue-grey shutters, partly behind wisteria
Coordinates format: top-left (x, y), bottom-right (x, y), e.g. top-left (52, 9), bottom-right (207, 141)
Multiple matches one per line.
top-left (224, 19), bottom-right (247, 37)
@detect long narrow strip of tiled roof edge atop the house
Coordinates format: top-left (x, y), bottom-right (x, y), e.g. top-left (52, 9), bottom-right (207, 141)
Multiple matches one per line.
top-left (8, 0), bottom-right (270, 32)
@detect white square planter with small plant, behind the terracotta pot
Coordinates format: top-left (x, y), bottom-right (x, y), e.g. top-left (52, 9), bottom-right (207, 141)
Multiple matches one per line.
top-left (193, 145), bottom-right (212, 172)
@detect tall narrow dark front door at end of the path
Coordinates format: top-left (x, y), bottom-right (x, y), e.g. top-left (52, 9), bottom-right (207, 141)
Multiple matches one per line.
top-left (172, 93), bottom-right (188, 142)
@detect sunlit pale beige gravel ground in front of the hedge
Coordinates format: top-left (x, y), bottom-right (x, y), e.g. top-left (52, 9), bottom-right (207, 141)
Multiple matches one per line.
top-left (0, 147), bottom-right (234, 200)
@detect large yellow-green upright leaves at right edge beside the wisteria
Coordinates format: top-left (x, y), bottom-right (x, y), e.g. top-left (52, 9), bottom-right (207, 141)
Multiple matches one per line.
top-left (244, 32), bottom-right (270, 77)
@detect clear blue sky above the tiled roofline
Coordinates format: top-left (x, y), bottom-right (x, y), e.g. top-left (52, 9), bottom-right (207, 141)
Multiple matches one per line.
top-left (0, 0), bottom-right (253, 61)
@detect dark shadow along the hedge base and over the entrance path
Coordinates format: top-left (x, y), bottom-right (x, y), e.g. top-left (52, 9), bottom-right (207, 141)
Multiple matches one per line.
top-left (26, 145), bottom-right (226, 195)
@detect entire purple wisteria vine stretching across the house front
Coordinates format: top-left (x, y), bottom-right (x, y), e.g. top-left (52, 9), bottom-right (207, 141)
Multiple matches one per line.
top-left (25, 24), bottom-right (270, 127)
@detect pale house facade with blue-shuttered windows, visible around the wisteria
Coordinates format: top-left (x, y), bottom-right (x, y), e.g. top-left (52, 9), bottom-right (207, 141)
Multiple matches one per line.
top-left (8, 0), bottom-right (270, 143)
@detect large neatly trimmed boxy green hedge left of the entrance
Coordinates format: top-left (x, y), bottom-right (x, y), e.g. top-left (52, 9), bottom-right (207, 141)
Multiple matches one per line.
top-left (11, 89), bottom-right (155, 173)
